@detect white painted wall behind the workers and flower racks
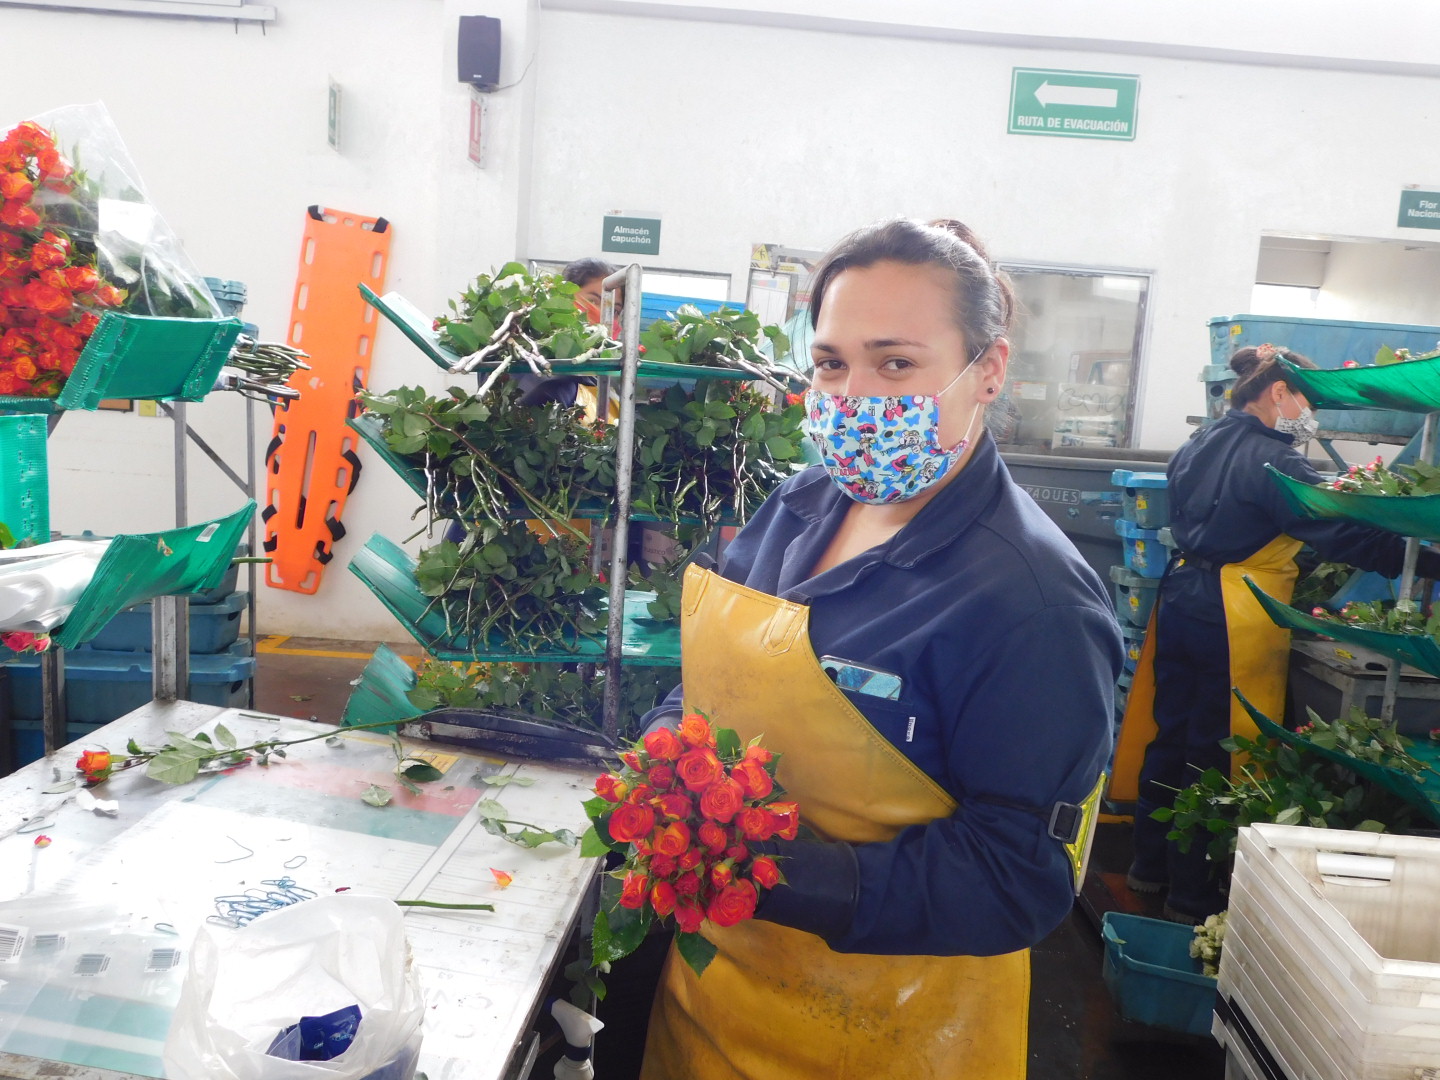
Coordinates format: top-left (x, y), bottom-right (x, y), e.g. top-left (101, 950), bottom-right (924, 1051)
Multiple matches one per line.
top-left (0, 0), bottom-right (1440, 638)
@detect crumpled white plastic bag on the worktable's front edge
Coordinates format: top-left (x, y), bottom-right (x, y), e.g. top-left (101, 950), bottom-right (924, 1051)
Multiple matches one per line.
top-left (164, 893), bottom-right (425, 1080)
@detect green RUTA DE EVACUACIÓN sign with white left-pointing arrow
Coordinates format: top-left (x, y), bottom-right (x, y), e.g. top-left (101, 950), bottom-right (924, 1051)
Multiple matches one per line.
top-left (1009, 68), bottom-right (1140, 140)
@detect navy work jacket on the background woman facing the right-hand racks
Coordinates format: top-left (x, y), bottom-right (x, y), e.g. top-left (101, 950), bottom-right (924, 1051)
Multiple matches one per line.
top-left (1165, 409), bottom-right (1440, 622)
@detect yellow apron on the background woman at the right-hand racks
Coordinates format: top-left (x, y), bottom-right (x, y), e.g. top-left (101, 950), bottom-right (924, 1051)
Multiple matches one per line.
top-left (1110, 536), bottom-right (1300, 802)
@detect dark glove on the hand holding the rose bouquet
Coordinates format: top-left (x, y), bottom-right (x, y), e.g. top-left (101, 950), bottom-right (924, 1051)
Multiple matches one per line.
top-left (749, 840), bottom-right (860, 940)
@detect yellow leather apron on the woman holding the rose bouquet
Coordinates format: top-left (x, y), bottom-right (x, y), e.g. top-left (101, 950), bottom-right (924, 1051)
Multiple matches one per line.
top-left (641, 566), bottom-right (1030, 1080)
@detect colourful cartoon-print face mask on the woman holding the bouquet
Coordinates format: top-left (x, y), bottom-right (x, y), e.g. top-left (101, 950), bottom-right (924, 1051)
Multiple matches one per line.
top-left (805, 357), bottom-right (981, 503)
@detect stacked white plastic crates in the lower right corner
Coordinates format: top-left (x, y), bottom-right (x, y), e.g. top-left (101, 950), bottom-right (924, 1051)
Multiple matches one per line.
top-left (1220, 825), bottom-right (1440, 1080)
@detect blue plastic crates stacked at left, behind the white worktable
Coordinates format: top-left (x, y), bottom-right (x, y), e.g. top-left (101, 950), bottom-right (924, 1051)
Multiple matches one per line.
top-left (0, 544), bottom-right (255, 768)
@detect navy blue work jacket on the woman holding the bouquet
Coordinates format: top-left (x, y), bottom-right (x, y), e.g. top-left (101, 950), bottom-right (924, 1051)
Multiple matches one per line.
top-left (650, 433), bottom-right (1123, 956)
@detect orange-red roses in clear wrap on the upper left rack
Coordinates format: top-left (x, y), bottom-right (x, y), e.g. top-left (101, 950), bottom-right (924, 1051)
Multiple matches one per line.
top-left (0, 121), bottom-right (125, 397)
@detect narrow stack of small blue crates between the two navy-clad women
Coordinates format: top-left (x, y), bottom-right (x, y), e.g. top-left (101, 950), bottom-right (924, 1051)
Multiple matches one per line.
top-left (1110, 469), bottom-right (1169, 714)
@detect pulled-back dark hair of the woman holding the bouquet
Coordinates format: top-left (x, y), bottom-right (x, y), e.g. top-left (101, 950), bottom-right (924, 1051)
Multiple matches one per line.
top-left (809, 217), bottom-right (1015, 357)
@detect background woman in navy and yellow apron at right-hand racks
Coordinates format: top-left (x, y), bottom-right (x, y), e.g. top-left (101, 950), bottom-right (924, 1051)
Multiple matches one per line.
top-left (1112, 346), bottom-right (1440, 923)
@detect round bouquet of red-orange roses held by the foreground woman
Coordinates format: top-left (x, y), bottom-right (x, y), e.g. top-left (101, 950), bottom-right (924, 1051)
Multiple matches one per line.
top-left (580, 713), bottom-right (799, 973)
